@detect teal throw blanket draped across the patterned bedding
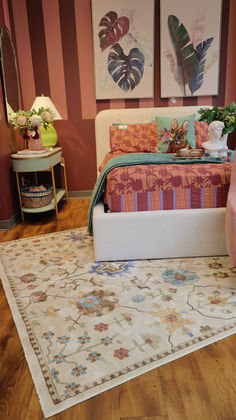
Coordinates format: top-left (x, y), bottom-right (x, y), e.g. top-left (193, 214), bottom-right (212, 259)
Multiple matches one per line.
top-left (88, 151), bottom-right (234, 236)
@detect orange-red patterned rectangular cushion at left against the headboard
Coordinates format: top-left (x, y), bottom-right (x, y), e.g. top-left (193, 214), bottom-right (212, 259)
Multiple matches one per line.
top-left (110, 122), bottom-right (158, 153)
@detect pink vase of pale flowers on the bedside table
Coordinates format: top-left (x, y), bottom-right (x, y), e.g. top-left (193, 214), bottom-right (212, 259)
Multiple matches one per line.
top-left (8, 107), bottom-right (54, 150)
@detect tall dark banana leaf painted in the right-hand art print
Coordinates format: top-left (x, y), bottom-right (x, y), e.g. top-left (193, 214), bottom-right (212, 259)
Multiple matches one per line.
top-left (168, 15), bottom-right (198, 95)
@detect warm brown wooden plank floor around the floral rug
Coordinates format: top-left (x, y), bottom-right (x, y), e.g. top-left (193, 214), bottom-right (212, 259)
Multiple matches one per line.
top-left (0, 199), bottom-right (236, 420)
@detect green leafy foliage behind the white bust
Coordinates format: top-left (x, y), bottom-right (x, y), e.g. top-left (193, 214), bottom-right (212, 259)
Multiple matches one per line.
top-left (198, 102), bottom-right (236, 135)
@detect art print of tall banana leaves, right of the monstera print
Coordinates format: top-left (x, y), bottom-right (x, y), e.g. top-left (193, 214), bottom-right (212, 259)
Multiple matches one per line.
top-left (160, 0), bottom-right (222, 98)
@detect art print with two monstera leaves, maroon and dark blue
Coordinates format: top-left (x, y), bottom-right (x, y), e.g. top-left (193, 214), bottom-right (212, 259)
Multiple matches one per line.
top-left (92, 0), bottom-right (154, 99)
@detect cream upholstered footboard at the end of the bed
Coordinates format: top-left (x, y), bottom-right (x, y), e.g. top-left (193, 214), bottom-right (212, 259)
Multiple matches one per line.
top-left (93, 202), bottom-right (227, 261)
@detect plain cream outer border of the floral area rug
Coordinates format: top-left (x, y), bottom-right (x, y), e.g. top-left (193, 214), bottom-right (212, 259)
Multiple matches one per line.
top-left (0, 241), bottom-right (236, 418)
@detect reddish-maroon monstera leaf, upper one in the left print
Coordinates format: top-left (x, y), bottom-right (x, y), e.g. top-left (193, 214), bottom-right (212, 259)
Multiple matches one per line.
top-left (98, 11), bottom-right (130, 51)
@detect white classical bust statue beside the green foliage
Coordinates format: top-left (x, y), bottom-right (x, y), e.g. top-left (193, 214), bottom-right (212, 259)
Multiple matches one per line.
top-left (203, 121), bottom-right (225, 157)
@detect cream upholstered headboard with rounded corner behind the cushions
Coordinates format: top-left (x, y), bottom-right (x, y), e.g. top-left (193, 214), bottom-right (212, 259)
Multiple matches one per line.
top-left (95, 105), bottom-right (209, 171)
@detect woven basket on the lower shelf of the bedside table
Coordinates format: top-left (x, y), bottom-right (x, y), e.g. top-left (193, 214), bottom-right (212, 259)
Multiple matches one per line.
top-left (21, 185), bottom-right (53, 208)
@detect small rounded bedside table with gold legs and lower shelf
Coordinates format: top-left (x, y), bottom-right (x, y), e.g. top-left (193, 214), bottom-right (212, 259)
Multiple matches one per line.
top-left (11, 147), bottom-right (68, 222)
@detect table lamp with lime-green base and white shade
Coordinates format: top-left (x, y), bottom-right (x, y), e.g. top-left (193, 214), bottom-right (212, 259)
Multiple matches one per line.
top-left (31, 95), bottom-right (62, 148)
